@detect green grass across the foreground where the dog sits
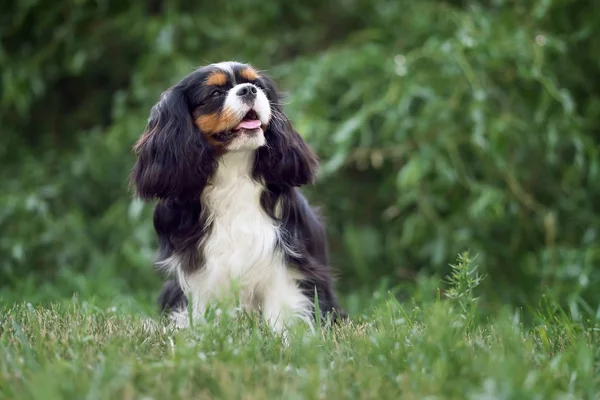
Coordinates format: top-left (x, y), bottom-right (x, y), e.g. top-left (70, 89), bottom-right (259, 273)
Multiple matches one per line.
top-left (0, 257), bottom-right (600, 400)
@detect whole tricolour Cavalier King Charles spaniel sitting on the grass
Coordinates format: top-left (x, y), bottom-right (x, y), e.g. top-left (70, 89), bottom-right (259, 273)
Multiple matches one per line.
top-left (131, 62), bottom-right (345, 330)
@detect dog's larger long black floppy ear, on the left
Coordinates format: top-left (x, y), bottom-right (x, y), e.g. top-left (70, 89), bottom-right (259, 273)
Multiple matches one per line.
top-left (130, 86), bottom-right (216, 200)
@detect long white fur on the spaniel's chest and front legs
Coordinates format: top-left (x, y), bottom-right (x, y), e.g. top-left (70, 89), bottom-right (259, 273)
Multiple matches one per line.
top-left (173, 152), bottom-right (312, 328)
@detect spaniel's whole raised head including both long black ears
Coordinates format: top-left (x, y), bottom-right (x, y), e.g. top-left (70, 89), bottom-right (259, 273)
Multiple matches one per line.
top-left (131, 62), bottom-right (318, 200)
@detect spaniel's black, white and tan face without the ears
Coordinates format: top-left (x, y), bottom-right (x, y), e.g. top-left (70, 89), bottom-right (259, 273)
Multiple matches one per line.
top-left (185, 63), bottom-right (276, 153)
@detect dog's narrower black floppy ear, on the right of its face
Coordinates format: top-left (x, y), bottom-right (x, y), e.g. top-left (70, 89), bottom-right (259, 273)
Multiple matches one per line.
top-left (254, 75), bottom-right (319, 187)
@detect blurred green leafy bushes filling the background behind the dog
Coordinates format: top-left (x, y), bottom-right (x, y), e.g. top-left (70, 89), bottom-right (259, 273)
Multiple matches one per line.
top-left (0, 0), bottom-right (600, 305)
